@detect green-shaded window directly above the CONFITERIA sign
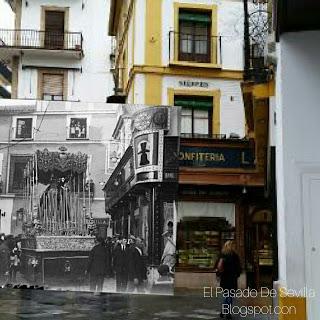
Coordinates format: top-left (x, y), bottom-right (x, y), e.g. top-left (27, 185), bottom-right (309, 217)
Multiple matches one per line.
top-left (174, 95), bottom-right (213, 137)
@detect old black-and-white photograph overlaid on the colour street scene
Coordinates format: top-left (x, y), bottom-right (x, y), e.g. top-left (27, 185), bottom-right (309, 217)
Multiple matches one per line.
top-left (1, 101), bottom-right (178, 295)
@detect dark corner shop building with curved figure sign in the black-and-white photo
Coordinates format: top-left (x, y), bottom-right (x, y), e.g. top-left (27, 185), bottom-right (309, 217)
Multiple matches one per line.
top-left (104, 105), bottom-right (179, 293)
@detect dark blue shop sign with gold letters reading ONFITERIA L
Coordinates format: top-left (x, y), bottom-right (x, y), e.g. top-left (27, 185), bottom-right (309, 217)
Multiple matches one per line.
top-left (179, 145), bottom-right (254, 169)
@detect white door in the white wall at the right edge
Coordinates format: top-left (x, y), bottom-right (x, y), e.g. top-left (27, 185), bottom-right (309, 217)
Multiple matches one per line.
top-left (303, 173), bottom-right (320, 320)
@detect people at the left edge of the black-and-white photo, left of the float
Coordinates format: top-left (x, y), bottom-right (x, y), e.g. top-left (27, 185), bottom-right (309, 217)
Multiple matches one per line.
top-left (0, 234), bottom-right (21, 286)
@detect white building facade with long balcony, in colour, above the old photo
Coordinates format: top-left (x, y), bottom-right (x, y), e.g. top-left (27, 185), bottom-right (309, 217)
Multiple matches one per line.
top-left (0, 0), bottom-right (113, 102)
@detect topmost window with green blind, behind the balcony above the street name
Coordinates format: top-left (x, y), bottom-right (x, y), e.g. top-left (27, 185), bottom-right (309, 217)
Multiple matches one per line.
top-left (179, 9), bottom-right (212, 63)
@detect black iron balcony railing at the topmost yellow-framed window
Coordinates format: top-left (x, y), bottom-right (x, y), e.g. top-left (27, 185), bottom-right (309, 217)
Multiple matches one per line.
top-left (169, 31), bottom-right (222, 65)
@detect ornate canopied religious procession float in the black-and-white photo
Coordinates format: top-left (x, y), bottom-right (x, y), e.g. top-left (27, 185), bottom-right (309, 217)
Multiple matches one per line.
top-left (21, 147), bottom-right (95, 287)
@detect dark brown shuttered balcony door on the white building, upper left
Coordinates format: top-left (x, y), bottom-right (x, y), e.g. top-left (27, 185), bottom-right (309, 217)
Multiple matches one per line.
top-left (44, 10), bottom-right (65, 49)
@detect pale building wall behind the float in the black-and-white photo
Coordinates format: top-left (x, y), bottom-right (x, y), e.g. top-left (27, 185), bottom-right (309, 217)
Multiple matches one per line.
top-left (0, 100), bottom-right (117, 235)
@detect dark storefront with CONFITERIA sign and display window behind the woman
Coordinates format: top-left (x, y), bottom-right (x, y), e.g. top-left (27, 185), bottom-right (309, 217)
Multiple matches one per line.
top-left (176, 139), bottom-right (276, 288)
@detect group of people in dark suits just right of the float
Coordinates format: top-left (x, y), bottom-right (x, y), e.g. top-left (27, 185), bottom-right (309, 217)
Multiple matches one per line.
top-left (86, 235), bottom-right (173, 293)
